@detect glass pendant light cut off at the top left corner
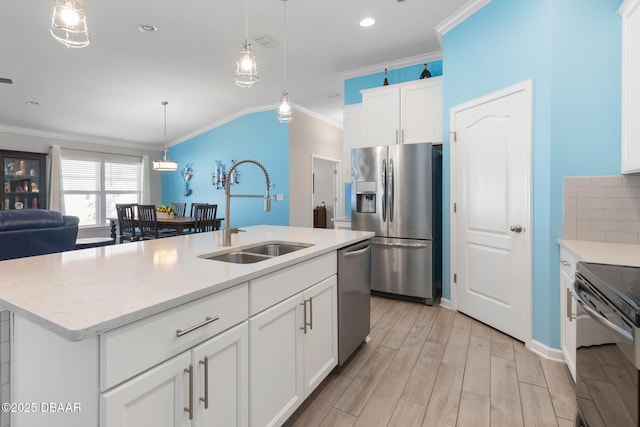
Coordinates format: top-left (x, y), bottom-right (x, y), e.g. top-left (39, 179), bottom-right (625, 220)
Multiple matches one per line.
top-left (49, 0), bottom-right (89, 48)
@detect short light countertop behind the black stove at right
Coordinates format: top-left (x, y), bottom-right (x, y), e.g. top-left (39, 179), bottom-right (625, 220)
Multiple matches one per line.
top-left (558, 240), bottom-right (640, 267)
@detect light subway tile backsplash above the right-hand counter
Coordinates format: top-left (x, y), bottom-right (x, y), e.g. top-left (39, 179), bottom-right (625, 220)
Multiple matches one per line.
top-left (562, 175), bottom-right (640, 244)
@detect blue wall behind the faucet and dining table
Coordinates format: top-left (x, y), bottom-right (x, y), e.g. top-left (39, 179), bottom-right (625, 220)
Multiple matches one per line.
top-left (162, 110), bottom-right (289, 227)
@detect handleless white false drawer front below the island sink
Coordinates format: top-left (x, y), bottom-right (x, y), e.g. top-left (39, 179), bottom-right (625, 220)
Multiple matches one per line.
top-left (249, 252), bottom-right (338, 316)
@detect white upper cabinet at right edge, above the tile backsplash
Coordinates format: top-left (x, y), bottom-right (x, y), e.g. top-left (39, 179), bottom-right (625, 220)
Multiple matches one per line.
top-left (618, 0), bottom-right (640, 173)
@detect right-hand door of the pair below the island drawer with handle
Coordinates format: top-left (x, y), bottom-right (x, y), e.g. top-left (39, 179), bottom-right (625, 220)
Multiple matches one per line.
top-left (192, 321), bottom-right (249, 427)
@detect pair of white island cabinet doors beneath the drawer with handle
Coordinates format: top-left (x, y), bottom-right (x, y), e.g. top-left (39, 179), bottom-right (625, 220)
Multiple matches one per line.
top-left (100, 321), bottom-right (249, 427)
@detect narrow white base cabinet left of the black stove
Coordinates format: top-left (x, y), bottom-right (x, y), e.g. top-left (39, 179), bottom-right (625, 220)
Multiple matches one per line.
top-left (560, 248), bottom-right (577, 381)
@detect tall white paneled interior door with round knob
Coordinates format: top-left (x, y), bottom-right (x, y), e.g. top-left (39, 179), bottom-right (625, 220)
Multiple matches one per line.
top-left (451, 81), bottom-right (532, 342)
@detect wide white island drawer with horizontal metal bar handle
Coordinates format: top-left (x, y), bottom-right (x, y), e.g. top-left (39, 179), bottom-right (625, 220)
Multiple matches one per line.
top-left (100, 283), bottom-right (249, 391)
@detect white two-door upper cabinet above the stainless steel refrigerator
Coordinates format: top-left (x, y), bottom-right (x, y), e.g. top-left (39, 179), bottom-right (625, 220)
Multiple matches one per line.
top-left (362, 77), bottom-right (442, 147)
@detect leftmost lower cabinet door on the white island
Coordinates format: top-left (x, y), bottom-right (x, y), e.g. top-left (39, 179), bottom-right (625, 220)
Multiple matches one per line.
top-left (100, 352), bottom-right (191, 427)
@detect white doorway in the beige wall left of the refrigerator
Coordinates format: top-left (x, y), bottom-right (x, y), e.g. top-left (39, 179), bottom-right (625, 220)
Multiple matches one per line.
top-left (311, 154), bottom-right (344, 228)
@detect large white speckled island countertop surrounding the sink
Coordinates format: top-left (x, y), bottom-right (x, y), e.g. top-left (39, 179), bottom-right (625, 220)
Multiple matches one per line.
top-left (0, 225), bottom-right (373, 341)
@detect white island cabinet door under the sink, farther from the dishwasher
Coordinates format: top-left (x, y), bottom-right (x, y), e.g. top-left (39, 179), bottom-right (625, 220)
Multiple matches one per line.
top-left (249, 293), bottom-right (304, 427)
